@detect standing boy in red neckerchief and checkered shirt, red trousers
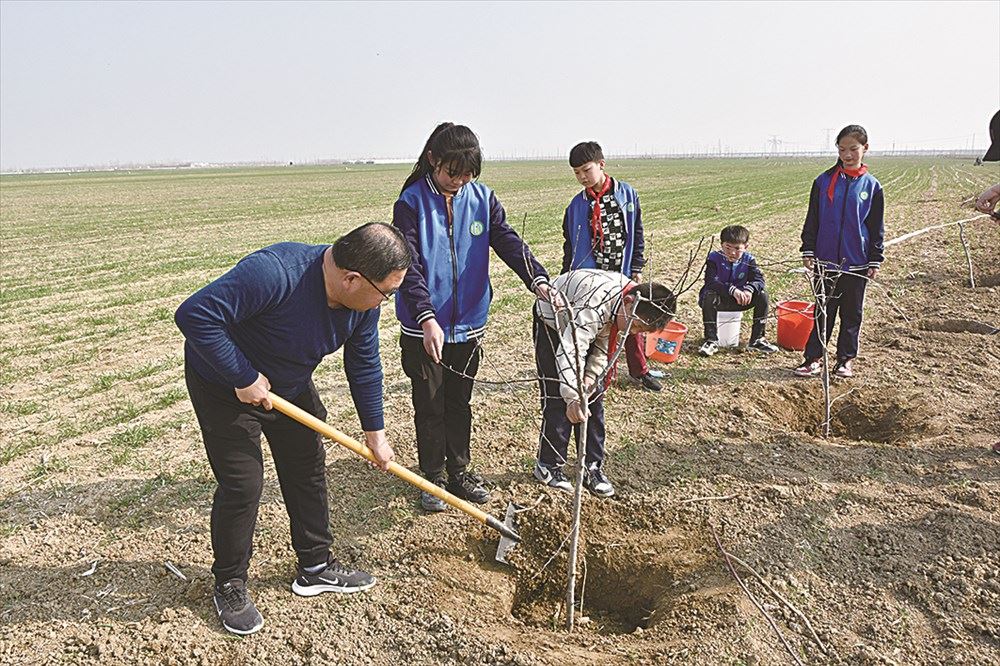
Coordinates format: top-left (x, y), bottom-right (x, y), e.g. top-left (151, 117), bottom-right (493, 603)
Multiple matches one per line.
top-left (562, 141), bottom-right (663, 391)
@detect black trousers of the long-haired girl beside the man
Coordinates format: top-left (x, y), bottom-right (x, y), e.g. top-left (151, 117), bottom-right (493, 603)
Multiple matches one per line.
top-left (399, 335), bottom-right (482, 479)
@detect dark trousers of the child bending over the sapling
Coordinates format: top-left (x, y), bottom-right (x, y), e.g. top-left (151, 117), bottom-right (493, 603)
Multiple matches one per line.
top-left (532, 313), bottom-right (604, 467)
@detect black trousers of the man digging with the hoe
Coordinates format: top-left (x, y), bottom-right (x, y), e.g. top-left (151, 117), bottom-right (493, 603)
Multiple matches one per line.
top-left (184, 363), bottom-right (333, 584)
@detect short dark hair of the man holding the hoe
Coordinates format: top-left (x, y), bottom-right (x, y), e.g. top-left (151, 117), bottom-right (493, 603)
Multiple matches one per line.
top-left (333, 222), bottom-right (413, 282)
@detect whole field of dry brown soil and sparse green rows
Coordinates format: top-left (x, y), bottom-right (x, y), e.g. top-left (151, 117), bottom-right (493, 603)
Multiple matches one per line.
top-left (0, 158), bottom-right (1000, 665)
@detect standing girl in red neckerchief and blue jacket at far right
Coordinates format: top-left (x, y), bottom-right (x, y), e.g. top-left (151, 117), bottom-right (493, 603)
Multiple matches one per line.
top-left (795, 125), bottom-right (885, 378)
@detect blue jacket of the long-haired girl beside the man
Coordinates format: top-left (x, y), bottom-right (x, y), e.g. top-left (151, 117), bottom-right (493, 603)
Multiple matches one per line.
top-left (392, 176), bottom-right (548, 342)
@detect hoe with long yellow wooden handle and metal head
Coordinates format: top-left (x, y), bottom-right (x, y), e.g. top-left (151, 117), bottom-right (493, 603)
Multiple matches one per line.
top-left (267, 392), bottom-right (521, 563)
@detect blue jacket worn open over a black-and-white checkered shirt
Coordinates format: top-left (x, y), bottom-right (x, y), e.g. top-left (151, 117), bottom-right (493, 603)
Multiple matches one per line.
top-left (562, 176), bottom-right (646, 276)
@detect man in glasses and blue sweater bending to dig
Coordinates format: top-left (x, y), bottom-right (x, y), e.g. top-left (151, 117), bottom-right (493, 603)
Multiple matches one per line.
top-left (175, 223), bottom-right (411, 635)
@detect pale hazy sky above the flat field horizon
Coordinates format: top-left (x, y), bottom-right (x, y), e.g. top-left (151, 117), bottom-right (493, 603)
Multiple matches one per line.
top-left (0, 0), bottom-right (1000, 170)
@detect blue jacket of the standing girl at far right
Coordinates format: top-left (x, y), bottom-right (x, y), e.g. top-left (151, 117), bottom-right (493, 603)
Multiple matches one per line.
top-left (800, 167), bottom-right (885, 271)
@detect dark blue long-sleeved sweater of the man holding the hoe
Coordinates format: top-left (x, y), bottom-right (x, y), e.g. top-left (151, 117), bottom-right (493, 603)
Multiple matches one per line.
top-left (174, 243), bottom-right (385, 430)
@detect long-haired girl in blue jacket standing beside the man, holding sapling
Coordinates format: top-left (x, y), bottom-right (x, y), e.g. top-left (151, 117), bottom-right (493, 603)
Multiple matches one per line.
top-left (392, 123), bottom-right (550, 511)
